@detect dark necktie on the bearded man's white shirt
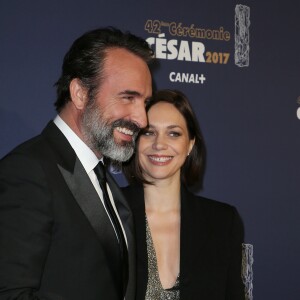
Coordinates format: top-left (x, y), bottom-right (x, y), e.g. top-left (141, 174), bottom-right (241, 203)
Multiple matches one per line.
top-left (94, 161), bottom-right (128, 296)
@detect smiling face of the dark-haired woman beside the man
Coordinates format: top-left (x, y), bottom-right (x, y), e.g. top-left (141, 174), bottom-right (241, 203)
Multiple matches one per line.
top-left (138, 102), bottom-right (194, 181)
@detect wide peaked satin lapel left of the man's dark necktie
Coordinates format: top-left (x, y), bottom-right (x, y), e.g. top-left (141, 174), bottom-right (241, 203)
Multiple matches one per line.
top-left (42, 122), bottom-right (118, 257)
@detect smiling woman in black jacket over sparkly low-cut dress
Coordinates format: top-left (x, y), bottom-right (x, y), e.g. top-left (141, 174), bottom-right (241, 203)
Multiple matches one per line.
top-left (123, 90), bottom-right (244, 300)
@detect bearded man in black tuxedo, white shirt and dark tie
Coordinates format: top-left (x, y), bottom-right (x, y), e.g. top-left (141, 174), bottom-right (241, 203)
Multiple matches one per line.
top-left (0, 28), bottom-right (152, 300)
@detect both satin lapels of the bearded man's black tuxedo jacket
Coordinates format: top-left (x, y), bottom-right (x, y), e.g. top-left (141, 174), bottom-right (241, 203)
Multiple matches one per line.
top-left (42, 122), bottom-right (136, 300)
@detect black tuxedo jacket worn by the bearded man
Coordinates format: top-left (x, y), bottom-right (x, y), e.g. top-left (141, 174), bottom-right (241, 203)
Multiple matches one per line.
top-left (0, 122), bottom-right (135, 300)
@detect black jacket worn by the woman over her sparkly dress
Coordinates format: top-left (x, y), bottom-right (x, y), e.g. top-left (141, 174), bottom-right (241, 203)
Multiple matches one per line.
top-left (123, 187), bottom-right (244, 300)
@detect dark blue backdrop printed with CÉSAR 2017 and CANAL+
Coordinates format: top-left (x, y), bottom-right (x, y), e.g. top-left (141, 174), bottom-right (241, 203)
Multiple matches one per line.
top-left (0, 0), bottom-right (300, 300)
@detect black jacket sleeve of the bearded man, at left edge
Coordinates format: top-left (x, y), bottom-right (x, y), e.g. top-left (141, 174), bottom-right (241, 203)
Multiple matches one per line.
top-left (0, 154), bottom-right (52, 300)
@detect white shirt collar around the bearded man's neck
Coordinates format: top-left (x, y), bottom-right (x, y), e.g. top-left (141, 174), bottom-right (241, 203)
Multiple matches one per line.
top-left (53, 115), bottom-right (99, 174)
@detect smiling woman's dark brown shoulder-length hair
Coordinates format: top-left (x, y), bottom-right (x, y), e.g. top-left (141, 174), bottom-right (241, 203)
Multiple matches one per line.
top-left (122, 90), bottom-right (205, 186)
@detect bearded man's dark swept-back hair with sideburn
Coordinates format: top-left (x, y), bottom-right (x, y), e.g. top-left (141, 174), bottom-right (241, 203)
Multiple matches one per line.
top-left (55, 27), bottom-right (153, 112)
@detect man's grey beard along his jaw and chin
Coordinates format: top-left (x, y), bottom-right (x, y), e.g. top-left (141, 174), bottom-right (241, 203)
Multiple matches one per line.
top-left (82, 103), bottom-right (137, 162)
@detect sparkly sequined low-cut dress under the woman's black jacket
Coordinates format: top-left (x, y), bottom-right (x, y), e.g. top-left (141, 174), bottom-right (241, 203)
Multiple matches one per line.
top-left (145, 217), bottom-right (180, 300)
